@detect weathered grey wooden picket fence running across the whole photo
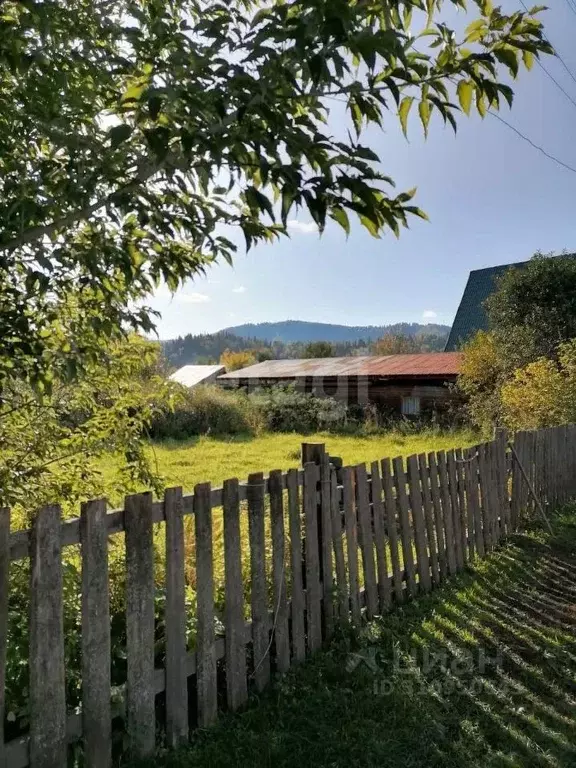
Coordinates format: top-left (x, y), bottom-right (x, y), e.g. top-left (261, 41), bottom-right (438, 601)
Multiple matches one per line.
top-left (0, 426), bottom-right (576, 768)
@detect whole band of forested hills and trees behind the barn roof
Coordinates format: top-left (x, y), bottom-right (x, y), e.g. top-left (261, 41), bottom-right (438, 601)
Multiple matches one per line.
top-left (162, 321), bottom-right (449, 368)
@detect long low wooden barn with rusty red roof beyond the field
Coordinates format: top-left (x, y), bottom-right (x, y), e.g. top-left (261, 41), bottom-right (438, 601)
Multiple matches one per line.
top-left (217, 352), bottom-right (462, 417)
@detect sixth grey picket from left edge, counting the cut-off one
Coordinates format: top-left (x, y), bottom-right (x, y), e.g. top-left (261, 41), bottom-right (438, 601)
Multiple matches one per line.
top-left (194, 483), bottom-right (218, 728)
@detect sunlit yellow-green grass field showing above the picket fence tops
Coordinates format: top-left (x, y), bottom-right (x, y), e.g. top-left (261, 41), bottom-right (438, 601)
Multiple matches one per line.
top-left (101, 431), bottom-right (478, 504)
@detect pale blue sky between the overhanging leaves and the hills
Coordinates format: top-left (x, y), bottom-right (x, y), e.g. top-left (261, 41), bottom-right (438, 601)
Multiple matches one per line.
top-left (152, 0), bottom-right (576, 338)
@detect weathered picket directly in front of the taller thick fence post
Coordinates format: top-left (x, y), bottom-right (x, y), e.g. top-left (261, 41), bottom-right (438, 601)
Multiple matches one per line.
top-left (303, 464), bottom-right (322, 653)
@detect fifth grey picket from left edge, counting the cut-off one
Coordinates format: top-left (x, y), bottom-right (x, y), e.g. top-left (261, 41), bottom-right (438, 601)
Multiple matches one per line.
top-left (164, 488), bottom-right (188, 749)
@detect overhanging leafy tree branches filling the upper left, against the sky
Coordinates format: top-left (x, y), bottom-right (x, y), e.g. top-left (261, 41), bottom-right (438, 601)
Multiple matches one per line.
top-left (0, 0), bottom-right (551, 381)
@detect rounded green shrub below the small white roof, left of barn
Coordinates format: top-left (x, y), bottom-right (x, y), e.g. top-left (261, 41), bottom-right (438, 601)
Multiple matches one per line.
top-left (150, 385), bottom-right (261, 440)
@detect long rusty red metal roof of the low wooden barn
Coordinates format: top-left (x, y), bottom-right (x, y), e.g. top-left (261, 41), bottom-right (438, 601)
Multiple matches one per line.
top-left (218, 352), bottom-right (462, 381)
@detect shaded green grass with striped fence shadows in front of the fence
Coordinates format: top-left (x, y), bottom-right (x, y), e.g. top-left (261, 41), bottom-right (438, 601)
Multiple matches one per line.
top-left (146, 508), bottom-right (576, 768)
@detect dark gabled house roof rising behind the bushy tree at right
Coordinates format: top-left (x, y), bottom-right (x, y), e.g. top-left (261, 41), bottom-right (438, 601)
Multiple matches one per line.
top-left (444, 253), bottom-right (576, 352)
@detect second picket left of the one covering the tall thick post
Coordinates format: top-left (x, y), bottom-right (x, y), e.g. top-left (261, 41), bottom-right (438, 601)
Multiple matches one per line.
top-left (270, 469), bottom-right (288, 674)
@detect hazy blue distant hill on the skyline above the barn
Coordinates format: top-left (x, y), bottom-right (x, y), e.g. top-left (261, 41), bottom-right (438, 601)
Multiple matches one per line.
top-left (223, 320), bottom-right (450, 343)
